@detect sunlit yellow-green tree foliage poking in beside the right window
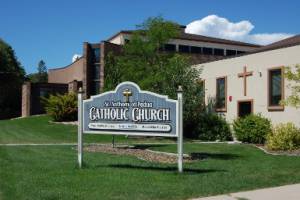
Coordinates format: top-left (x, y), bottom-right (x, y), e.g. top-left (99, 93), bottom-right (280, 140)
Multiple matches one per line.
top-left (281, 65), bottom-right (300, 108)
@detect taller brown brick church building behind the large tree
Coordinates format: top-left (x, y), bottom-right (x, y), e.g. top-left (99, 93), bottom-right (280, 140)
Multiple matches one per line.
top-left (48, 26), bottom-right (261, 97)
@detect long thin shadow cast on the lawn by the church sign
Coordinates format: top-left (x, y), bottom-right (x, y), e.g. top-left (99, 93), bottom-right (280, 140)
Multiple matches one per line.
top-left (108, 164), bottom-right (225, 174)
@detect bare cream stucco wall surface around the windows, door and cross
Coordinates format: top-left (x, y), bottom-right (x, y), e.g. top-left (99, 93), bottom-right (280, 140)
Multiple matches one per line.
top-left (196, 45), bottom-right (300, 127)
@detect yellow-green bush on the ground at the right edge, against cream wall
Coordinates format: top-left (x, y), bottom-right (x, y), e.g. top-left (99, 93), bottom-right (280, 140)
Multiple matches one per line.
top-left (267, 123), bottom-right (300, 150)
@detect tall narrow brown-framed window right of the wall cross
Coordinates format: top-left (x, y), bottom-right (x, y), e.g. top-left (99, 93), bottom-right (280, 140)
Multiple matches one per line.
top-left (268, 67), bottom-right (284, 111)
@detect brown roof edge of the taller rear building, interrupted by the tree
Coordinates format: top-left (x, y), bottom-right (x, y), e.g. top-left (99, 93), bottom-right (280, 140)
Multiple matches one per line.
top-left (107, 30), bottom-right (262, 48)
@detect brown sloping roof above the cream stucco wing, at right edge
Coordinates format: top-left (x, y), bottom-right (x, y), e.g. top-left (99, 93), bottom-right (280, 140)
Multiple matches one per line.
top-left (248, 35), bottom-right (300, 54)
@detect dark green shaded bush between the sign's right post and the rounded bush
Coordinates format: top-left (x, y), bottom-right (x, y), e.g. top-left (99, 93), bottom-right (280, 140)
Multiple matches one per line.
top-left (193, 113), bottom-right (232, 141)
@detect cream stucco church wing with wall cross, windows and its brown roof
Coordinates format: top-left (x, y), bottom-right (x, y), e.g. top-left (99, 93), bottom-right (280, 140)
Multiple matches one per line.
top-left (196, 35), bottom-right (300, 127)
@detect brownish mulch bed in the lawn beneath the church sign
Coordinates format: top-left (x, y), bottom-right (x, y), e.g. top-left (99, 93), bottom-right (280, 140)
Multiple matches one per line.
top-left (84, 145), bottom-right (195, 164)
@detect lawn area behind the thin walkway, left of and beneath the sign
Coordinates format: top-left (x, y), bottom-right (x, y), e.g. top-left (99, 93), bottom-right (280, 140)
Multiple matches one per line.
top-left (0, 116), bottom-right (174, 144)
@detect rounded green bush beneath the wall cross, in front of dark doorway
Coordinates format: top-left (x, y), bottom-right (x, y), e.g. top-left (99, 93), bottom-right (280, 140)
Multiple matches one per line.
top-left (233, 115), bottom-right (272, 144)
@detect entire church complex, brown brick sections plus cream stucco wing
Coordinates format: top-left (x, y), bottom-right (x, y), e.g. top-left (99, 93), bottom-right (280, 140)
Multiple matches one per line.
top-left (22, 26), bottom-right (300, 126)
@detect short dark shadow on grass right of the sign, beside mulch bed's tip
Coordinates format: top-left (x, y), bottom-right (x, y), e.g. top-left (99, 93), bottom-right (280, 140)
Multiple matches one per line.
top-left (190, 152), bottom-right (241, 160)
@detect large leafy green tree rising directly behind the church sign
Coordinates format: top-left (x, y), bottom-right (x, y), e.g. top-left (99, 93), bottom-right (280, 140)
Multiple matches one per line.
top-left (104, 17), bottom-right (203, 136)
